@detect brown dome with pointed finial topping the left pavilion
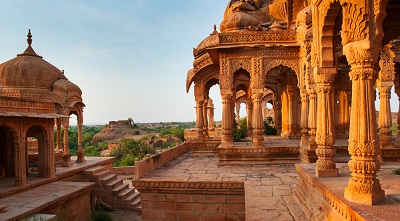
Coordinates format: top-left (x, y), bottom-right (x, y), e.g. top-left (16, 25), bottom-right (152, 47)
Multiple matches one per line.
top-left (0, 32), bottom-right (65, 89)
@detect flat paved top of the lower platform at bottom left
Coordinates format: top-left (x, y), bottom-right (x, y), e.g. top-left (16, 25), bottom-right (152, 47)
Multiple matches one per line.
top-left (0, 182), bottom-right (95, 221)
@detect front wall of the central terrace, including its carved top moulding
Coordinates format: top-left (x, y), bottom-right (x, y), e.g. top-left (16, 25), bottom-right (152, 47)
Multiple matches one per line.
top-left (133, 180), bottom-right (245, 221)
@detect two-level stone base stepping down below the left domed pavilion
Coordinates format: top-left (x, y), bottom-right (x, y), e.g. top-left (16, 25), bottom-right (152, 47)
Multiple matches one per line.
top-left (0, 157), bottom-right (114, 221)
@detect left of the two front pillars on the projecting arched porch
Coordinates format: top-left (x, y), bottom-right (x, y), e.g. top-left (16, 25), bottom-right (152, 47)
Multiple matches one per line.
top-left (221, 94), bottom-right (234, 148)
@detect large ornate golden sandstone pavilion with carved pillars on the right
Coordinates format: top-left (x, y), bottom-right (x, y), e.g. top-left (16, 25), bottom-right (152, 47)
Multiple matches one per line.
top-left (185, 0), bottom-right (400, 211)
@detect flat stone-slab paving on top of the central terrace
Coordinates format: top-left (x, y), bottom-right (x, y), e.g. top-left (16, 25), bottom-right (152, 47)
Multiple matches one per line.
top-left (141, 152), bottom-right (307, 221)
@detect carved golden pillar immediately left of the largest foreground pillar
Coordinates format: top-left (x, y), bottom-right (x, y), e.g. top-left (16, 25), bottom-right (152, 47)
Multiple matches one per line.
top-left (314, 68), bottom-right (339, 177)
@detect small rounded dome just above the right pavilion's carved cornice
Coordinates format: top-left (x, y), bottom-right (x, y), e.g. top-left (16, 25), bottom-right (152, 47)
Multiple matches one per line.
top-left (220, 11), bottom-right (260, 32)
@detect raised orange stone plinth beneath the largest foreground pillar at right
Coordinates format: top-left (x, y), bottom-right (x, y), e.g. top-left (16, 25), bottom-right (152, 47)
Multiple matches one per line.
top-left (294, 163), bottom-right (400, 221)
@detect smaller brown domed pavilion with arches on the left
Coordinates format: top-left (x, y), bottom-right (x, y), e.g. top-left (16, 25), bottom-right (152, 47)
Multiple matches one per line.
top-left (0, 30), bottom-right (85, 186)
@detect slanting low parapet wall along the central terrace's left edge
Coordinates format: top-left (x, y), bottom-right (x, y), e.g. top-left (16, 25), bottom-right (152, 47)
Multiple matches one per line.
top-left (134, 142), bottom-right (192, 179)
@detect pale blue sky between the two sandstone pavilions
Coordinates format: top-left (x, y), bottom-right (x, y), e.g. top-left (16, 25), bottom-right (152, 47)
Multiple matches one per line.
top-left (0, 0), bottom-right (228, 124)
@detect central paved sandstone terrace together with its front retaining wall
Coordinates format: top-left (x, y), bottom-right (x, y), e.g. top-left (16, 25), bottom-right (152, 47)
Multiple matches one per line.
top-left (132, 151), bottom-right (306, 221)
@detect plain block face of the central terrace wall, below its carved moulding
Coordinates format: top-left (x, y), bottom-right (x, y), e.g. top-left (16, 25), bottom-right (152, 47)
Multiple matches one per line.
top-left (140, 190), bottom-right (245, 221)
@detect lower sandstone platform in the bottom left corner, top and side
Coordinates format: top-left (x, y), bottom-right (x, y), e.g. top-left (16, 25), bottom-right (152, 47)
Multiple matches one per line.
top-left (0, 182), bottom-right (95, 221)
